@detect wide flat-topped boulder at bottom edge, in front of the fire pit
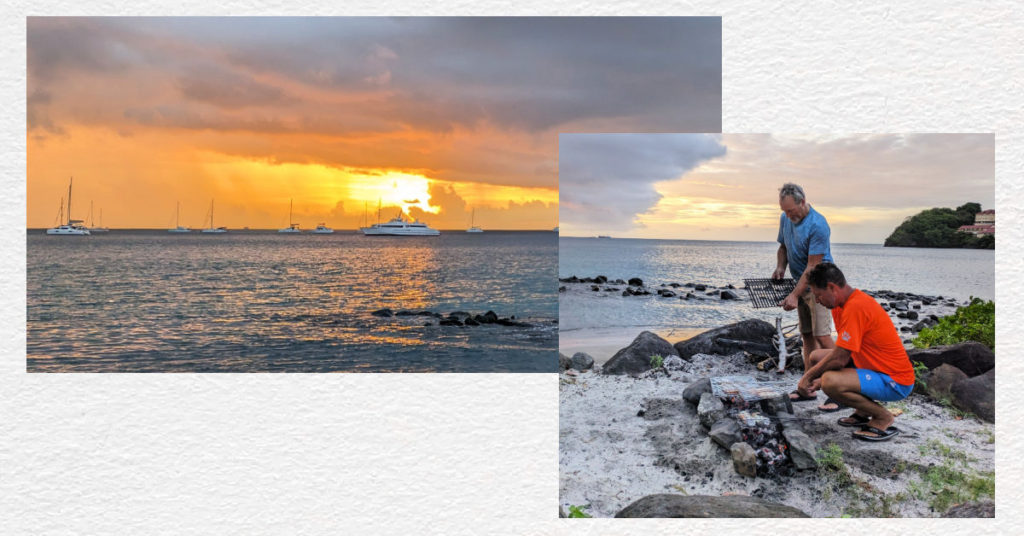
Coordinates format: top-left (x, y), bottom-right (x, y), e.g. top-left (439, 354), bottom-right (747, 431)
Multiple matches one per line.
top-left (615, 493), bottom-right (809, 518)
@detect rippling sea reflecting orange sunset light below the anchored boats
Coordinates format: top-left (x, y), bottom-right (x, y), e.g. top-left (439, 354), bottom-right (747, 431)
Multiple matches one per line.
top-left (27, 230), bottom-right (558, 372)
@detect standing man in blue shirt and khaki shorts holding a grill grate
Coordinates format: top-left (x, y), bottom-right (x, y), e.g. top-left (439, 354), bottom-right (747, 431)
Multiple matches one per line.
top-left (772, 182), bottom-right (840, 411)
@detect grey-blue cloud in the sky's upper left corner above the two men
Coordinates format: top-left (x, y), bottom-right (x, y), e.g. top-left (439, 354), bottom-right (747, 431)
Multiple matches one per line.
top-left (558, 134), bottom-right (726, 231)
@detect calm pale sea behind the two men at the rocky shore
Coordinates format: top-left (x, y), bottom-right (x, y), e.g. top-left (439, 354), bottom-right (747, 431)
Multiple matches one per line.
top-left (558, 237), bottom-right (995, 347)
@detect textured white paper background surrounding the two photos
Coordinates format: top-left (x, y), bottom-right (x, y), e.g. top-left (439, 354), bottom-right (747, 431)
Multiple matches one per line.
top-left (0, 0), bottom-right (1024, 535)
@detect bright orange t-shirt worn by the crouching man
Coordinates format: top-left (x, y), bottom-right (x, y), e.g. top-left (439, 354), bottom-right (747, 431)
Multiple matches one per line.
top-left (833, 289), bottom-right (913, 385)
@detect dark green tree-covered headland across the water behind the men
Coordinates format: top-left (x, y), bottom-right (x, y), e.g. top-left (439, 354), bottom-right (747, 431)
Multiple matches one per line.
top-left (885, 203), bottom-right (995, 249)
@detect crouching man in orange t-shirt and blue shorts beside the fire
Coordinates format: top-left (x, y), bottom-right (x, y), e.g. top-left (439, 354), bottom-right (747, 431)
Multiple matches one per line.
top-left (797, 262), bottom-right (913, 441)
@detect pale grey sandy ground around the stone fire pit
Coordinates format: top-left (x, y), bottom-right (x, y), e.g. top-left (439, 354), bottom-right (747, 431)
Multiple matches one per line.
top-left (559, 350), bottom-right (995, 517)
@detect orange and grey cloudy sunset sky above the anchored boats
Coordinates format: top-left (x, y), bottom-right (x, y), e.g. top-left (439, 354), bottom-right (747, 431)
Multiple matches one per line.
top-left (27, 17), bottom-right (721, 230)
